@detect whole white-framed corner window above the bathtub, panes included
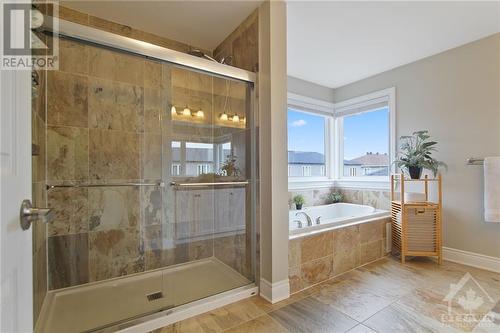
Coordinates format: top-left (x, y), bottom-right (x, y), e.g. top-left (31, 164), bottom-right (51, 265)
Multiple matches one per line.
top-left (288, 88), bottom-right (396, 189)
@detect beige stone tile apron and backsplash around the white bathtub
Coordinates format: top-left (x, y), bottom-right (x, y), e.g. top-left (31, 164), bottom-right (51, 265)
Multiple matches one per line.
top-left (288, 188), bottom-right (390, 293)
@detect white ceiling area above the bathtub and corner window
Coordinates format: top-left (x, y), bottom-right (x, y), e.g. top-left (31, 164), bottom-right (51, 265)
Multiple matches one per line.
top-left (287, 1), bottom-right (500, 88)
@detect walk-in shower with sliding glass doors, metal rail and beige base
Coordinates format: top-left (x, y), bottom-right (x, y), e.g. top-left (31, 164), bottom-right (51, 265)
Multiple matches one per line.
top-left (35, 21), bottom-right (256, 333)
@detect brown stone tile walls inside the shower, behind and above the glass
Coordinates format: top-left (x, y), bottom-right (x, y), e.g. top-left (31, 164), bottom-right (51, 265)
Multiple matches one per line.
top-left (33, 0), bottom-right (258, 298)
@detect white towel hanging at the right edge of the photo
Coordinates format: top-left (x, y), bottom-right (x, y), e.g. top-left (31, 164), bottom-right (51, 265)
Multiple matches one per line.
top-left (484, 156), bottom-right (500, 222)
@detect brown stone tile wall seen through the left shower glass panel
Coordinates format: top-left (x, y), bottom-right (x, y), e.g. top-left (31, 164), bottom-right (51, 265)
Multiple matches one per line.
top-left (46, 40), bottom-right (170, 289)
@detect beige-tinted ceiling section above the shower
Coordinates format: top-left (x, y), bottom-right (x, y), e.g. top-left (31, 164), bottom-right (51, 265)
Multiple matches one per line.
top-left (62, 0), bottom-right (262, 50)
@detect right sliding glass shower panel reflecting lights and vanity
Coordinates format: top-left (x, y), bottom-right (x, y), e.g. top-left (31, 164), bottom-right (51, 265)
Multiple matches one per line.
top-left (165, 65), bottom-right (254, 305)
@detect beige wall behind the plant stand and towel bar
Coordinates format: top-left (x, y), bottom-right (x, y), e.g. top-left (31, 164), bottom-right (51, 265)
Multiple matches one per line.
top-left (334, 34), bottom-right (500, 257)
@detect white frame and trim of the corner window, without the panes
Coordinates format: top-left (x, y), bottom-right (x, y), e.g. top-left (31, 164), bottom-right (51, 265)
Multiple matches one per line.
top-left (287, 87), bottom-right (396, 190)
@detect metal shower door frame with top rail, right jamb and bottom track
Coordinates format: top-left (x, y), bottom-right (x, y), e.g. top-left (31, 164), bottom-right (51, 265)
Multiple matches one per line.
top-left (41, 18), bottom-right (259, 332)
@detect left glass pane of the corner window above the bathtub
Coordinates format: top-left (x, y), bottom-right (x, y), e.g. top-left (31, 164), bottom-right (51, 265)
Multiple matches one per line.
top-left (288, 109), bottom-right (326, 177)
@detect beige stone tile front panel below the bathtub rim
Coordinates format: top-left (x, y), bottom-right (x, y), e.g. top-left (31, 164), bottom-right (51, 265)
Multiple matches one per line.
top-left (288, 218), bottom-right (390, 293)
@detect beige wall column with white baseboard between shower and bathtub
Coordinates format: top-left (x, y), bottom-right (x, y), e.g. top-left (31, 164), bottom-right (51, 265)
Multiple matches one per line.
top-left (258, 1), bottom-right (290, 303)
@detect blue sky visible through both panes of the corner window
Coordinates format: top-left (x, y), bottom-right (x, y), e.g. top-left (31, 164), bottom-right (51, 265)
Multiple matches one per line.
top-left (288, 108), bottom-right (389, 159)
